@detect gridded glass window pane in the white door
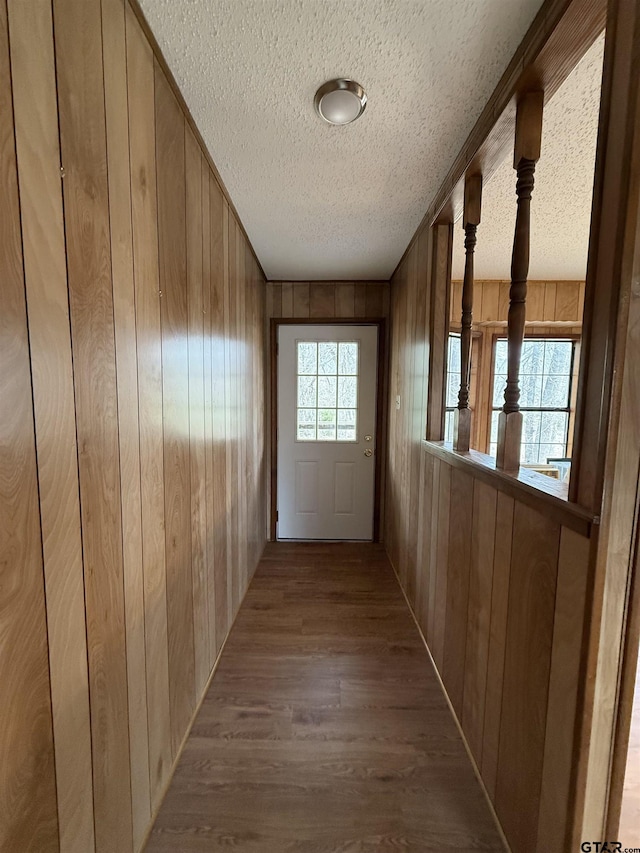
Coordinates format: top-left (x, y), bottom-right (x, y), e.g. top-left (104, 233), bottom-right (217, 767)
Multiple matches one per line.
top-left (296, 341), bottom-right (360, 442)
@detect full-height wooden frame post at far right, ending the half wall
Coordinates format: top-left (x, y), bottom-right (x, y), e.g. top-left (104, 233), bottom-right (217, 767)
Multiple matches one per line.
top-left (575, 0), bottom-right (640, 838)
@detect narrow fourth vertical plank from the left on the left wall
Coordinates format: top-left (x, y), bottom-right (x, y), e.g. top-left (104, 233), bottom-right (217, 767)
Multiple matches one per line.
top-left (102, 0), bottom-right (151, 849)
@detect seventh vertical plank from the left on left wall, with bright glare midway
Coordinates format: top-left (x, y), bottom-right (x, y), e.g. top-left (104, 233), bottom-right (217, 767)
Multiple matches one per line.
top-left (185, 126), bottom-right (209, 696)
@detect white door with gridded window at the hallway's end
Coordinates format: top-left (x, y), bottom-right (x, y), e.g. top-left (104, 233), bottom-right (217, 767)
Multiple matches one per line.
top-left (277, 325), bottom-right (378, 540)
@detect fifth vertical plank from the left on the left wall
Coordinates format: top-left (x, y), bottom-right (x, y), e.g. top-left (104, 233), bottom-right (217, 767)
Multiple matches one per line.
top-left (125, 5), bottom-right (171, 809)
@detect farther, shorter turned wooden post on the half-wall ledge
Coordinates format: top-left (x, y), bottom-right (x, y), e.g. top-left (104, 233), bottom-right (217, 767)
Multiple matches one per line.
top-left (453, 175), bottom-right (482, 452)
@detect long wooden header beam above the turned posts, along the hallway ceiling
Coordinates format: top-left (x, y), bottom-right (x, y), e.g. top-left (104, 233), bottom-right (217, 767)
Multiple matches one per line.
top-left (391, 0), bottom-right (607, 278)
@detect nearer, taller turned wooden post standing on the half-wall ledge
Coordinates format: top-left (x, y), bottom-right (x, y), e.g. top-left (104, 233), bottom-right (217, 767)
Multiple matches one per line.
top-left (496, 92), bottom-right (544, 471)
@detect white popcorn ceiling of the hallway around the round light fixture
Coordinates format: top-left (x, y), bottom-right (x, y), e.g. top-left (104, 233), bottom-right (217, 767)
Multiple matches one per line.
top-left (140, 0), bottom-right (552, 280)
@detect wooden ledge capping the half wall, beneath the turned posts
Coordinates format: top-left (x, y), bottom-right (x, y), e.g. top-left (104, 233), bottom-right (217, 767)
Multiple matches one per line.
top-left (422, 441), bottom-right (599, 536)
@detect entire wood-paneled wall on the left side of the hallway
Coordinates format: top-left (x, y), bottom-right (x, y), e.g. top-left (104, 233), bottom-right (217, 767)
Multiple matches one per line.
top-left (0, 0), bottom-right (266, 853)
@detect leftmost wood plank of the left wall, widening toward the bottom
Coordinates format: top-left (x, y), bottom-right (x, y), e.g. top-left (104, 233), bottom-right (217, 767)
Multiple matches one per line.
top-left (0, 2), bottom-right (59, 853)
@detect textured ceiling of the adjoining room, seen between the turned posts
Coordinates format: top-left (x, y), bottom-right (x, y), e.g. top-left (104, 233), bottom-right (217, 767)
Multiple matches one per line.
top-left (453, 36), bottom-right (604, 281)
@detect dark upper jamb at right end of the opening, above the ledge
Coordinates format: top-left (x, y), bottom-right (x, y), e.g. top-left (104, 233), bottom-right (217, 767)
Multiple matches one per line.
top-left (571, 0), bottom-right (640, 511)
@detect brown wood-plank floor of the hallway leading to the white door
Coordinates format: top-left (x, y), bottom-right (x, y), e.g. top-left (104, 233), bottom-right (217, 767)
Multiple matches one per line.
top-left (146, 543), bottom-right (504, 853)
